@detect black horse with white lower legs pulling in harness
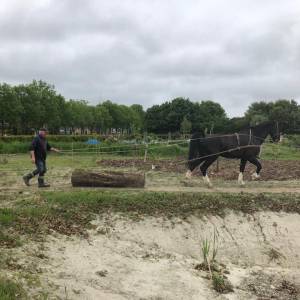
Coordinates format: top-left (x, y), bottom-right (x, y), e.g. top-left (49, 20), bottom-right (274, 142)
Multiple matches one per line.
top-left (186, 122), bottom-right (280, 186)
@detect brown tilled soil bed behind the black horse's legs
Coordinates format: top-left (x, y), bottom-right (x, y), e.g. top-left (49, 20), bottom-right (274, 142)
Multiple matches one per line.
top-left (98, 157), bottom-right (300, 180)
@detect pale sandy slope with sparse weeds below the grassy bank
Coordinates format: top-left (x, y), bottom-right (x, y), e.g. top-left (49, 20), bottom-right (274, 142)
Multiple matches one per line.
top-left (13, 212), bottom-right (300, 300)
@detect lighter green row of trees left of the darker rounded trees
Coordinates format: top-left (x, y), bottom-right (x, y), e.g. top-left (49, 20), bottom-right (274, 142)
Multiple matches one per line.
top-left (0, 80), bottom-right (145, 134)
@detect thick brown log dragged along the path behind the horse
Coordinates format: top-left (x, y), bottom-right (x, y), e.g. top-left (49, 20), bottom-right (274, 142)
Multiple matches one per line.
top-left (71, 170), bottom-right (145, 188)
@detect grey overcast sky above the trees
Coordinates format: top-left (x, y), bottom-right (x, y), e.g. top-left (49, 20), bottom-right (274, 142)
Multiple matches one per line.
top-left (0, 0), bottom-right (300, 117)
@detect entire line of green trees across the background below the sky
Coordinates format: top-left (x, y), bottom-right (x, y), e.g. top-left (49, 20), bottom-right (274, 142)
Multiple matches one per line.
top-left (0, 81), bottom-right (300, 135)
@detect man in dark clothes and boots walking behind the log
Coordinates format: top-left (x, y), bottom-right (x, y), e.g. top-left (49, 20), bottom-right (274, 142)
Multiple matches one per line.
top-left (23, 128), bottom-right (60, 187)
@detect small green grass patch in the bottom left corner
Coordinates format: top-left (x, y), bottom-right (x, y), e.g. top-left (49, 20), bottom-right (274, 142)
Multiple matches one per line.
top-left (0, 277), bottom-right (29, 300)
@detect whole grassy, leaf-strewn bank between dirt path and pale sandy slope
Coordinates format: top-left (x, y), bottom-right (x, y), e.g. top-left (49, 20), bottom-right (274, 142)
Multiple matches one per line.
top-left (0, 190), bottom-right (300, 247)
